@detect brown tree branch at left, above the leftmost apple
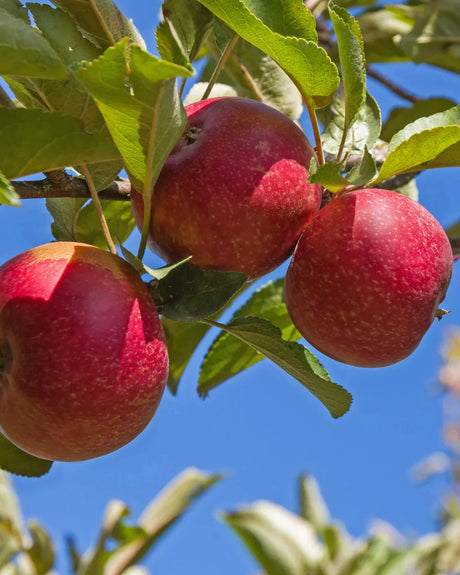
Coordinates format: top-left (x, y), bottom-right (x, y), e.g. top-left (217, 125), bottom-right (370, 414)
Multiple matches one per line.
top-left (11, 170), bottom-right (131, 201)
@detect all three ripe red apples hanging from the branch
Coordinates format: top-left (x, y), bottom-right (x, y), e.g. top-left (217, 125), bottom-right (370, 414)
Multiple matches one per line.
top-left (0, 94), bottom-right (453, 461)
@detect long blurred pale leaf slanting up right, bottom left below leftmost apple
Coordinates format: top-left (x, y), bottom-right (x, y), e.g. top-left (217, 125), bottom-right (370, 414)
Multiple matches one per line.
top-left (104, 468), bottom-right (222, 575)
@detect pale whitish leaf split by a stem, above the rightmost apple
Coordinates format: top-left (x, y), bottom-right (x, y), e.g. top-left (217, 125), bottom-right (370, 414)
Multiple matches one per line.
top-left (320, 92), bottom-right (381, 155)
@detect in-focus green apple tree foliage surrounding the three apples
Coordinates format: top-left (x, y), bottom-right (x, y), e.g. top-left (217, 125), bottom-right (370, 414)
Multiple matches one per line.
top-left (0, 0), bottom-right (460, 476)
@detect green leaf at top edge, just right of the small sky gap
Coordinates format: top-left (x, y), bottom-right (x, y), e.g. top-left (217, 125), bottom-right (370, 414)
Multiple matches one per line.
top-left (155, 0), bottom-right (213, 67)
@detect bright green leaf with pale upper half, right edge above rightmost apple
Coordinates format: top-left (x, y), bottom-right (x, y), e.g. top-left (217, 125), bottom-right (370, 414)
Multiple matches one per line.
top-left (372, 105), bottom-right (460, 184)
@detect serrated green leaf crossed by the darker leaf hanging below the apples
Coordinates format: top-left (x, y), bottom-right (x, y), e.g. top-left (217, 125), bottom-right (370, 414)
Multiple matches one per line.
top-left (198, 278), bottom-right (302, 396)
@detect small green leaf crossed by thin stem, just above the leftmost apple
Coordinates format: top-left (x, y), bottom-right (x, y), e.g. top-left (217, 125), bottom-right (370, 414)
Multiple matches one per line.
top-left (76, 200), bottom-right (136, 249)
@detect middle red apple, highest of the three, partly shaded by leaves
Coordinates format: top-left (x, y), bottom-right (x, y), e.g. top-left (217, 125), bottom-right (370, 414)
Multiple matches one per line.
top-left (131, 97), bottom-right (322, 278)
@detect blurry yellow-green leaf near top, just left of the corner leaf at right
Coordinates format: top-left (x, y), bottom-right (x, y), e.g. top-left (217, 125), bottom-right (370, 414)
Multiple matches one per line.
top-left (358, 4), bottom-right (418, 63)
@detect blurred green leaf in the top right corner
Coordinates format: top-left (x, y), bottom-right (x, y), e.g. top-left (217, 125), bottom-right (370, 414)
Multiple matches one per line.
top-left (399, 0), bottom-right (460, 73)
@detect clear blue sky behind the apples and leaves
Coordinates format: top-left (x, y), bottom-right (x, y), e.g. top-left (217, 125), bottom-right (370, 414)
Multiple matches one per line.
top-left (0, 0), bottom-right (460, 575)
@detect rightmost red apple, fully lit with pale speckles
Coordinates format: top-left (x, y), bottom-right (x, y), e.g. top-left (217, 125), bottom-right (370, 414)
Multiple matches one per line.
top-left (285, 189), bottom-right (453, 367)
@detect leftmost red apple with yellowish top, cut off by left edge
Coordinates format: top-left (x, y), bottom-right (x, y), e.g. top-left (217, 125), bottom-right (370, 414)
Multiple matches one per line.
top-left (0, 242), bottom-right (168, 461)
